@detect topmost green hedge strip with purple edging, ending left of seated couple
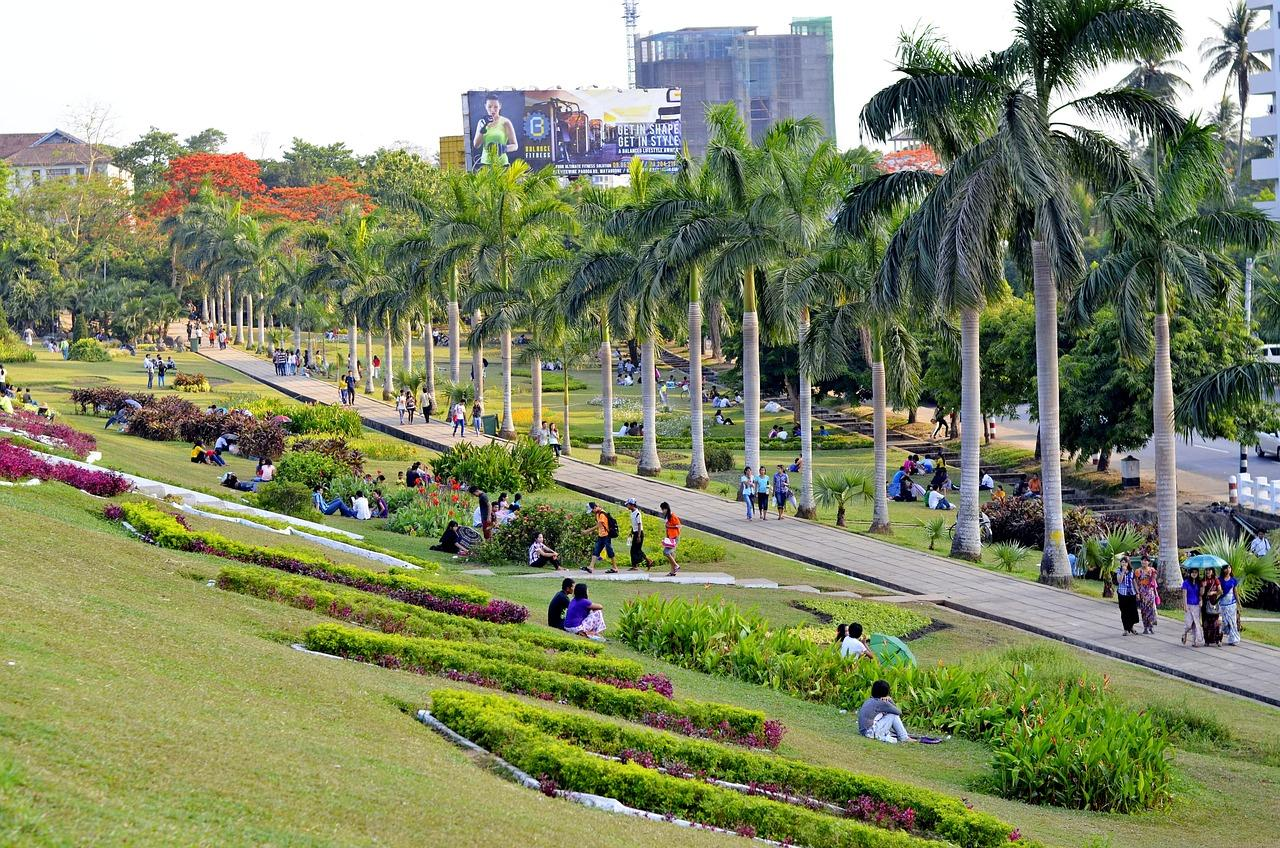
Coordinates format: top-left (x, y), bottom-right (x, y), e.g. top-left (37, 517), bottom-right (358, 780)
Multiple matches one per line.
top-left (110, 502), bottom-right (519, 624)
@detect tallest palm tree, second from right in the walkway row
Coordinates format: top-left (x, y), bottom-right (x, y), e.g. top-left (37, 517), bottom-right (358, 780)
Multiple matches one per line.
top-left (861, 0), bottom-right (1181, 585)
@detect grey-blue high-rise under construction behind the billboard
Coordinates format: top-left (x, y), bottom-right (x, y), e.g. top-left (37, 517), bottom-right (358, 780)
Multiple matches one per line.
top-left (635, 18), bottom-right (836, 156)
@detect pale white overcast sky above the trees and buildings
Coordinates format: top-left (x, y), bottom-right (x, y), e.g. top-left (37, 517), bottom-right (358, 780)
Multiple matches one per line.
top-left (0, 0), bottom-right (1268, 158)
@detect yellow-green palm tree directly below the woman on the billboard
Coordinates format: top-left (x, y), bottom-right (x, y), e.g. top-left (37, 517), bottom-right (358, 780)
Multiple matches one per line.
top-left (436, 160), bottom-right (571, 438)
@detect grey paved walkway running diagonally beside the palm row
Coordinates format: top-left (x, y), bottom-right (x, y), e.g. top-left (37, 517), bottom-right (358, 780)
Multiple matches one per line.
top-left (201, 348), bottom-right (1280, 706)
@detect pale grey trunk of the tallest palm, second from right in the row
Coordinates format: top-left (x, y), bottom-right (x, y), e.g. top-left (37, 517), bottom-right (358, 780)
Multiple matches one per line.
top-left (1032, 240), bottom-right (1071, 587)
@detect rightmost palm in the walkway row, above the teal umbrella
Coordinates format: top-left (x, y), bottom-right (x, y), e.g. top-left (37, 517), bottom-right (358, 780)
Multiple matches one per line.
top-left (1076, 122), bottom-right (1280, 606)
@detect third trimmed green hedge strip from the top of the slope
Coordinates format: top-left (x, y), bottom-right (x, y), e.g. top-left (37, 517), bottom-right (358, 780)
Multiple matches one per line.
top-left (303, 624), bottom-right (765, 740)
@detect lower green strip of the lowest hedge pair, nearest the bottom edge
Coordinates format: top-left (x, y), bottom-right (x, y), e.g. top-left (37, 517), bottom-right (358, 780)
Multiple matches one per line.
top-left (431, 690), bottom-right (962, 848)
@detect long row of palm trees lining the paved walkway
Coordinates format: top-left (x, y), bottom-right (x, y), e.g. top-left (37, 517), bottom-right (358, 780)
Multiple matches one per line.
top-left (170, 0), bottom-right (1275, 602)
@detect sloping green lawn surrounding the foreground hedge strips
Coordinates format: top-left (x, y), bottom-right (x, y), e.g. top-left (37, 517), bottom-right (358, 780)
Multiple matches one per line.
top-left (0, 484), bottom-right (1280, 848)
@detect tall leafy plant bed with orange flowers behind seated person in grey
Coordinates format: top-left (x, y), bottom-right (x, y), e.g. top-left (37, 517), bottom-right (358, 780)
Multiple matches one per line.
top-left (617, 596), bottom-right (1171, 812)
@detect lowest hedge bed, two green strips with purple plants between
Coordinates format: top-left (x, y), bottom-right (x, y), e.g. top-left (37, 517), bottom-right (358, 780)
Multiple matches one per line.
top-left (431, 689), bottom-right (1003, 848)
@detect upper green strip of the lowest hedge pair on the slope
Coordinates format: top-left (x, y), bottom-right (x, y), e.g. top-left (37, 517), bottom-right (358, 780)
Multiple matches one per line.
top-left (431, 689), bottom-right (1014, 848)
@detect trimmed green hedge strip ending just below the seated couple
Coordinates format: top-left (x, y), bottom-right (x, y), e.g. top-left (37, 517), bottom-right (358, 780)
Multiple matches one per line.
top-left (218, 565), bottom-right (602, 656)
